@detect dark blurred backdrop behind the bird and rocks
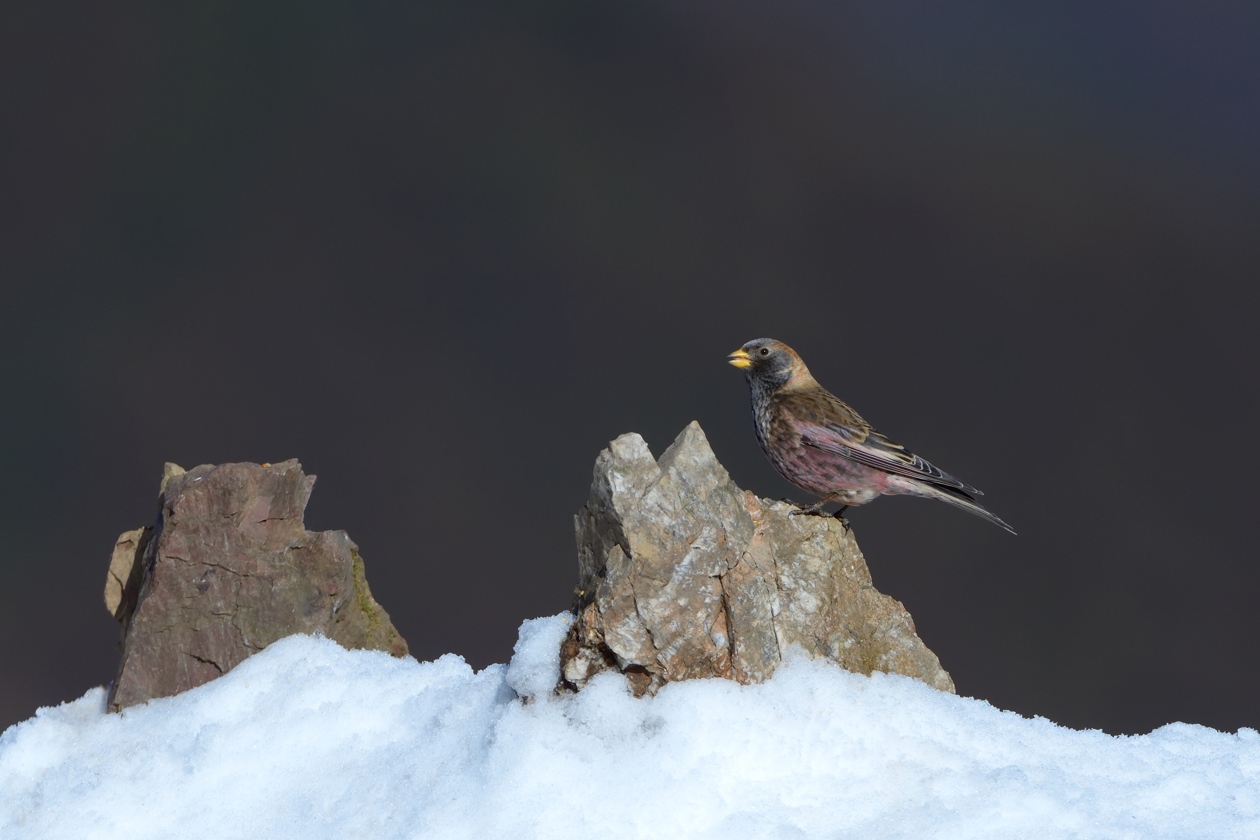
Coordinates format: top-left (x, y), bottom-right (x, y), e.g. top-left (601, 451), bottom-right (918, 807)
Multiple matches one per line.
top-left (0, 0), bottom-right (1260, 733)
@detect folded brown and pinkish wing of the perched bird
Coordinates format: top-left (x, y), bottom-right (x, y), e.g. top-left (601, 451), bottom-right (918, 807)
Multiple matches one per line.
top-left (784, 389), bottom-right (984, 496)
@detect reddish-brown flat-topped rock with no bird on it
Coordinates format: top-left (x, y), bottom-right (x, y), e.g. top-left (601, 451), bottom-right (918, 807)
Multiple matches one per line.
top-left (105, 461), bottom-right (407, 712)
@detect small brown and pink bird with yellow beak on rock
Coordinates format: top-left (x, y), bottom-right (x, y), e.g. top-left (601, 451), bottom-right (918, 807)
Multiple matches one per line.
top-left (727, 339), bottom-right (1016, 534)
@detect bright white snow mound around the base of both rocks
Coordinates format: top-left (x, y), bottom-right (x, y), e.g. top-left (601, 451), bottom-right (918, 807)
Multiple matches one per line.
top-left (0, 616), bottom-right (1260, 840)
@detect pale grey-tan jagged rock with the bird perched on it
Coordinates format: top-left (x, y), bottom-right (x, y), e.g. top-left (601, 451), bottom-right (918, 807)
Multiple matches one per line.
top-left (561, 422), bottom-right (954, 695)
